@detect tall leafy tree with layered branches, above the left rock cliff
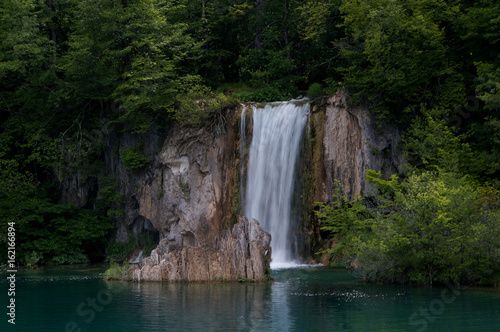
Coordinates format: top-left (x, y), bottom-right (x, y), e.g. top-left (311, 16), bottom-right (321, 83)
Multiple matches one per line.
top-left (63, 0), bottom-right (199, 132)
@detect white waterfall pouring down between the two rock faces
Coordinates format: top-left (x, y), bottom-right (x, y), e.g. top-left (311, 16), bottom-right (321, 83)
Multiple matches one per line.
top-left (244, 101), bottom-right (309, 267)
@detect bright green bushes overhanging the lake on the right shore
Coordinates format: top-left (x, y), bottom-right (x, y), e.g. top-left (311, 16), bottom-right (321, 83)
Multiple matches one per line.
top-left (319, 172), bottom-right (500, 284)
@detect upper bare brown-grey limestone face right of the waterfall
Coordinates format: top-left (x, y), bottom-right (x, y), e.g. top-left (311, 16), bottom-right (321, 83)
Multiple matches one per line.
top-left (313, 91), bottom-right (402, 202)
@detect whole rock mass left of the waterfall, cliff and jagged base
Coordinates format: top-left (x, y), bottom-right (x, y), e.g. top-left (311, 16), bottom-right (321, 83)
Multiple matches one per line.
top-left (114, 110), bottom-right (271, 281)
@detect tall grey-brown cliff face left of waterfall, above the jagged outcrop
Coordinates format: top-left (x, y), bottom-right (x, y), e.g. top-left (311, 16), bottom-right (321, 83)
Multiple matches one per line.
top-left (136, 127), bottom-right (237, 247)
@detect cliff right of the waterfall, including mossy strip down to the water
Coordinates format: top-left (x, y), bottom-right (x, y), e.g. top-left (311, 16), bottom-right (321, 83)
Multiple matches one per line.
top-left (302, 91), bottom-right (403, 265)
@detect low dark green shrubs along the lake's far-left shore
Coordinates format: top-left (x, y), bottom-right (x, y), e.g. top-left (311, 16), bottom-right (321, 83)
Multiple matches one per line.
top-left (0, 198), bottom-right (114, 266)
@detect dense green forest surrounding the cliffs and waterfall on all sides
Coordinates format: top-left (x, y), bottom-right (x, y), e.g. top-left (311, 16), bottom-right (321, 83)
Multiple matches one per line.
top-left (0, 0), bottom-right (500, 283)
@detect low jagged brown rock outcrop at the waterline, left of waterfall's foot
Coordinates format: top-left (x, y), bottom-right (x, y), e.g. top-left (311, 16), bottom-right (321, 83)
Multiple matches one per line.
top-left (132, 217), bottom-right (271, 282)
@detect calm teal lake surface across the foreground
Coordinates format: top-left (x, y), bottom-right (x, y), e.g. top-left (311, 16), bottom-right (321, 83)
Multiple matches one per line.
top-left (0, 266), bottom-right (500, 331)
